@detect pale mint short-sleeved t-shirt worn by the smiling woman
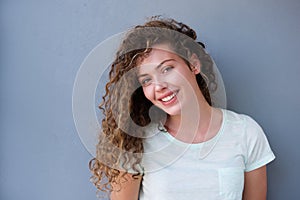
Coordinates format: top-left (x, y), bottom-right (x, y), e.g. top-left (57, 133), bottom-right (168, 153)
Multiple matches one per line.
top-left (139, 110), bottom-right (275, 200)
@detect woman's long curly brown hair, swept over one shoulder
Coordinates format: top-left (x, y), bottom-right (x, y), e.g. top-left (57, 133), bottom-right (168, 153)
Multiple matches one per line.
top-left (89, 17), bottom-right (216, 197)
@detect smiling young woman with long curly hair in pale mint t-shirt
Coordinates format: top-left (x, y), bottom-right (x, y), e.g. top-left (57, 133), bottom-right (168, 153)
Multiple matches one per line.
top-left (90, 17), bottom-right (275, 200)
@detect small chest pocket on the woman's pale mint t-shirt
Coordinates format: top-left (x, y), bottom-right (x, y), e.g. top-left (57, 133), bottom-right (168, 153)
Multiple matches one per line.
top-left (218, 168), bottom-right (244, 200)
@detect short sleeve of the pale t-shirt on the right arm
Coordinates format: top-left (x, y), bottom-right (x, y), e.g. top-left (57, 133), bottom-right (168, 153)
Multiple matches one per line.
top-left (245, 116), bottom-right (275, 172)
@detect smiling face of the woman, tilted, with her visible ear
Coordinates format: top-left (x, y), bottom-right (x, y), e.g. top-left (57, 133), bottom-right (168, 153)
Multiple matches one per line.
top-left (137, 45), bottom-right (202, 116)
